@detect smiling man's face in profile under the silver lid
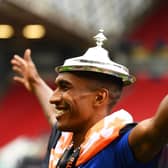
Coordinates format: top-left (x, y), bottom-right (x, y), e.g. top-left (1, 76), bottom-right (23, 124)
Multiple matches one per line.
top-left (50, 72), bottom-right (96, 132)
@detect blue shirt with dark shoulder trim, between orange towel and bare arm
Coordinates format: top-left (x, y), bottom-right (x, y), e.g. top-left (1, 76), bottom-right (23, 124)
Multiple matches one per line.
top-left (80, 123), bottom-right (156, 168)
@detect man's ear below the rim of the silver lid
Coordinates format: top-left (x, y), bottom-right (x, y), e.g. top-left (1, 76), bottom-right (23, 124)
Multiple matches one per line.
top-left (94, 88), bottom-right (109, 106)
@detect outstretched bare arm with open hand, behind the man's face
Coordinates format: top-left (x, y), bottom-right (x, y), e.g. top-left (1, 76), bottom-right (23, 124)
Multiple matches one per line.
top-left (11, 49), bottom-right (56, 125)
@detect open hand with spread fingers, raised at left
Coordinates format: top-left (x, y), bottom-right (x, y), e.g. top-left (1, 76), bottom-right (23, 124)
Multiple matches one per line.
top-left (11, 49), bottom-right (40, 91)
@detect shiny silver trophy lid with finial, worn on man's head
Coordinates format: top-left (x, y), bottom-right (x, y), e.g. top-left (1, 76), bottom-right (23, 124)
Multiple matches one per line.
top-left (56, 29), bottom-right (135, 85)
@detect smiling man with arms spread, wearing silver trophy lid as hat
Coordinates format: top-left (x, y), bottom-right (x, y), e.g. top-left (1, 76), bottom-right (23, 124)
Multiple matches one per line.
top-left (12, 32), bottom-right (168, 168)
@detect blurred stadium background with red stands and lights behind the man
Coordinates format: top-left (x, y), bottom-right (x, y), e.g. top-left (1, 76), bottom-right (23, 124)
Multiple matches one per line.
top-left (0, 0), bottom-right (168, 168)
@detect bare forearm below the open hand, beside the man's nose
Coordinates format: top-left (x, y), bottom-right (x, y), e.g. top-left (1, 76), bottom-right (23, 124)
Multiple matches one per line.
top-left (31, 77), bottom-right (56, 125)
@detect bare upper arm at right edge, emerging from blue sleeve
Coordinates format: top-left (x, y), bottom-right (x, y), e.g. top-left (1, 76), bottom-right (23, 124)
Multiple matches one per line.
top-left (129, 96), bottom-right (168, 162)
